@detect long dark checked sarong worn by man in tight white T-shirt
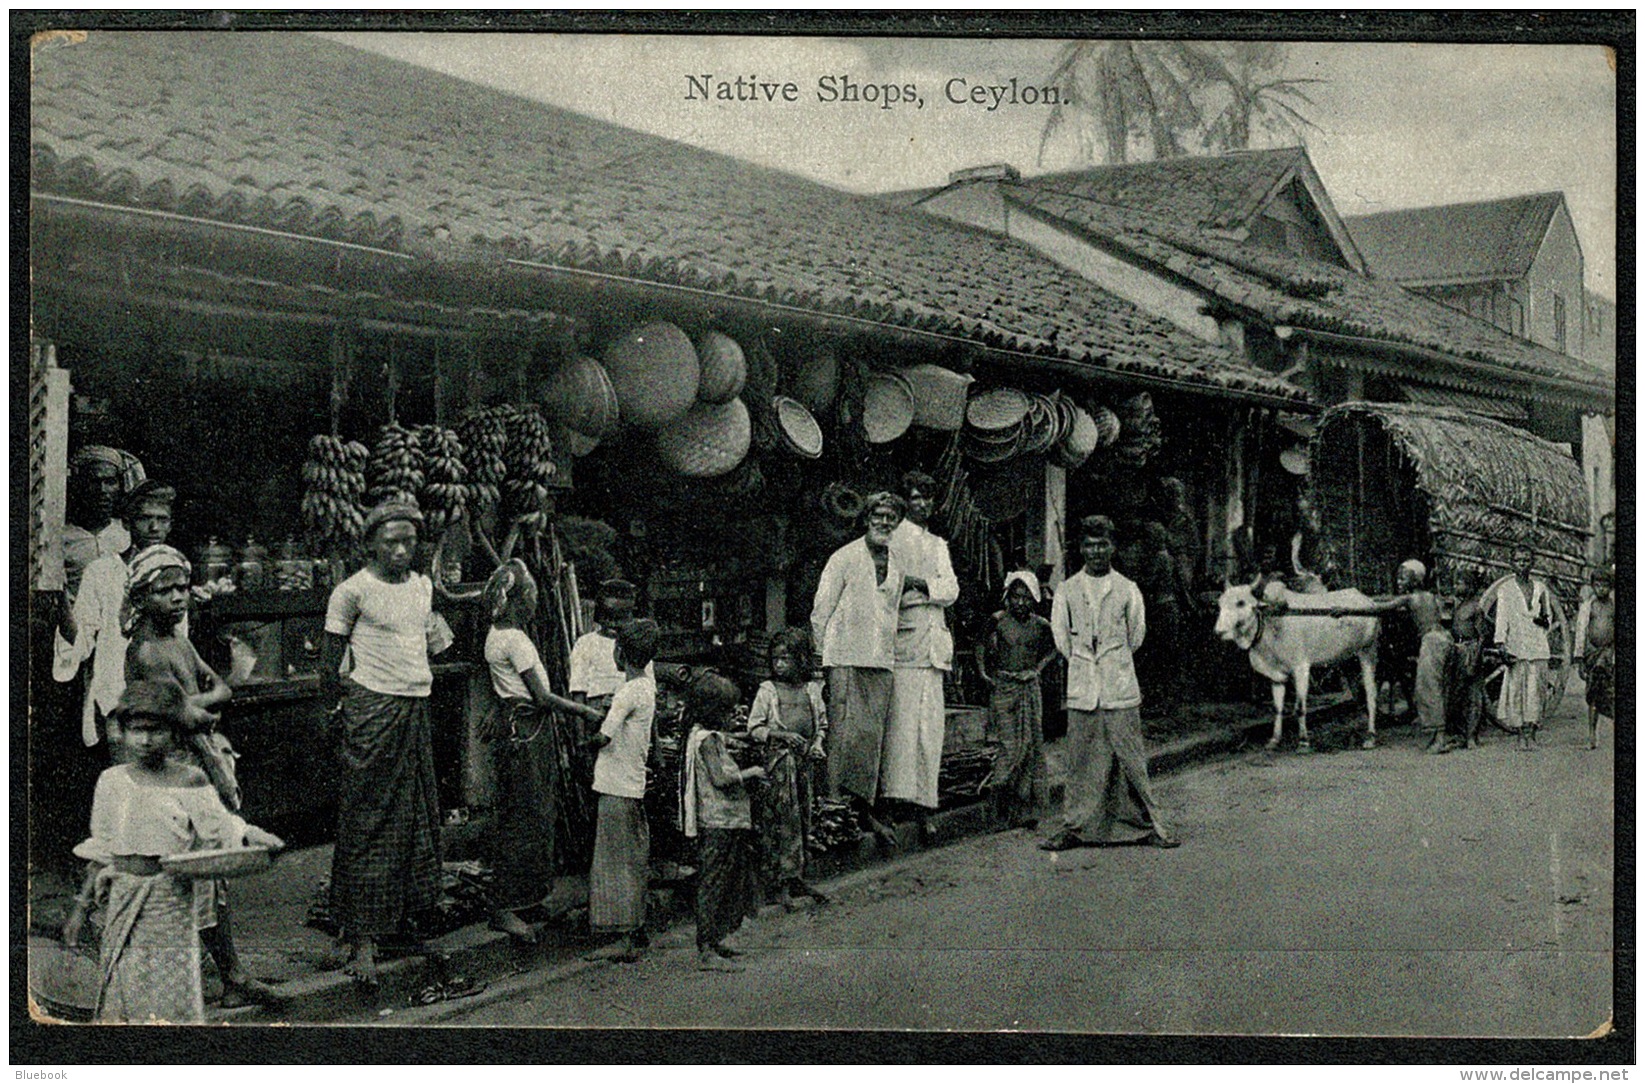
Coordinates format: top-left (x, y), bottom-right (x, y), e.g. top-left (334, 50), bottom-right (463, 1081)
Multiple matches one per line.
top-left (331, 681), bottom-right (439, 938)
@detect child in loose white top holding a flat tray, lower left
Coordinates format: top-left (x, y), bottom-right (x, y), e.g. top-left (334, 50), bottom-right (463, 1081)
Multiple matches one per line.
top-left (63, 679), bottom-right (285, 1023)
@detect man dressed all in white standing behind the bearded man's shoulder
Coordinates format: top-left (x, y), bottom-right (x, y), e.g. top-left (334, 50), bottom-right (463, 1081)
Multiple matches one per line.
top-left (880, 470), bottom-right (959, 825)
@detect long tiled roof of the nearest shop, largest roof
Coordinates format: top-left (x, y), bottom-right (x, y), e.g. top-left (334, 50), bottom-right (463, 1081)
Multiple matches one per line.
top-left (31, 31), bottom-right (1304, 407)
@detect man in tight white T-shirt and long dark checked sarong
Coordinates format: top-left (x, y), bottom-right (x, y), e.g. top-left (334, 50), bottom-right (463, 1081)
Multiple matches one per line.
top-left (319, 502), bottom-right (447, 987)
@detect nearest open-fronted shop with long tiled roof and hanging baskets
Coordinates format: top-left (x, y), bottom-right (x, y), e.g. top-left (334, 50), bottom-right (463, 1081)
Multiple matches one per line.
top-left (30, 33), bottom-right (1311, 848)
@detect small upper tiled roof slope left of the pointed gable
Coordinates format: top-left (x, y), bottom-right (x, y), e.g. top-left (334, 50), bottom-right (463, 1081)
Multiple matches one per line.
top-left (1025, 146), bottom-right (1308, 230)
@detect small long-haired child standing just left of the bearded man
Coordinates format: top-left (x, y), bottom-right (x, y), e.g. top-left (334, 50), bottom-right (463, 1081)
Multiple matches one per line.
top-left (748, 628), bottom-right (827, 910)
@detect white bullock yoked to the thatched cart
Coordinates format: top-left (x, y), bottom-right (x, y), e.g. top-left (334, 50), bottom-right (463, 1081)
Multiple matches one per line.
top-left (1216, 577), bottom-right (1379, 752)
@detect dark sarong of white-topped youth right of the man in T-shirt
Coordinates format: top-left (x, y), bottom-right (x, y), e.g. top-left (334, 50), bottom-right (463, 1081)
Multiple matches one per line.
top-left (487, 701), bottom-right (559, 910)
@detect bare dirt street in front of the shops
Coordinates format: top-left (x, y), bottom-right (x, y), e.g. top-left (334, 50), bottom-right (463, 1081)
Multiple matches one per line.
top-left (430, 696), bottom-right (1612, 1036)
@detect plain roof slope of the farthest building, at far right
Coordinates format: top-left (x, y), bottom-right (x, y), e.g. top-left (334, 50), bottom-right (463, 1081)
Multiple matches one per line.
top-left (1346, 192), bottom-right (1564, 283)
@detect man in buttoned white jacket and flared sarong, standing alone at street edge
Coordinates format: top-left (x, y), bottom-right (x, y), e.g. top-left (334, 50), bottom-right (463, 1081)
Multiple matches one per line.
top-left (1040, 515), bottom-right (1178, 850)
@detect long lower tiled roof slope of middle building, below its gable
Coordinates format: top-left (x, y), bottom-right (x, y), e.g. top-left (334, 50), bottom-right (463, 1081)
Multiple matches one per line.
top-left (1005, 186), bottom-right (1615, 396)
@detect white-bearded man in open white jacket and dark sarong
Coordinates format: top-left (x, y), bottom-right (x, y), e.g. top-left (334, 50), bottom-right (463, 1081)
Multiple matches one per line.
top-left (811, 493), bottom-right (908, 847)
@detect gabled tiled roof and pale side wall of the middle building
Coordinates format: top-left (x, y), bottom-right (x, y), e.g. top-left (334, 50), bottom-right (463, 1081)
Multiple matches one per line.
top-left (895, 148), bottom-right (1615, 588)
